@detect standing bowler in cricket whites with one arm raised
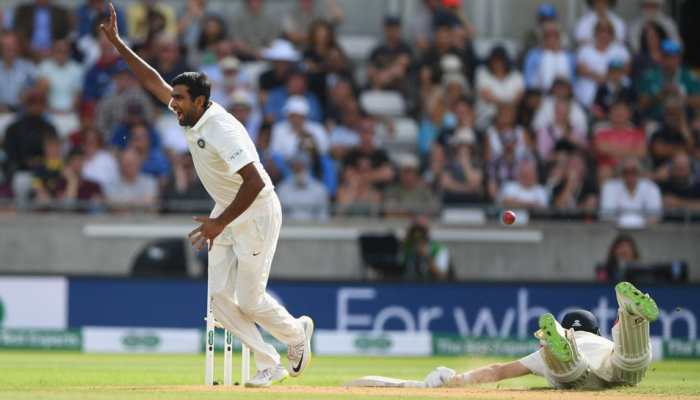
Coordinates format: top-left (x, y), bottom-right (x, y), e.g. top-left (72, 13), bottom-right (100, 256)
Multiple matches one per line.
top-left (101, 4), bottom-right (313, 387)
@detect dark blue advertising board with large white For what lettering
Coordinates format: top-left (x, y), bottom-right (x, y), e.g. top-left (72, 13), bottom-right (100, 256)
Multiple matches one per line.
top-left (68, 278), bottom-right (700, 339)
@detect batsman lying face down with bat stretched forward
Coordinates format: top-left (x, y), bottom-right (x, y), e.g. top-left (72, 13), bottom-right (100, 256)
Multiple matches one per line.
top-left (348, 282), bottom-right (659, 389)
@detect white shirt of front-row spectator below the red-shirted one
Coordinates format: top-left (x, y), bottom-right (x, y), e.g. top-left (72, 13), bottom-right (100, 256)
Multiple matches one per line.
top-left (600, 178), bottom-right (662, 217)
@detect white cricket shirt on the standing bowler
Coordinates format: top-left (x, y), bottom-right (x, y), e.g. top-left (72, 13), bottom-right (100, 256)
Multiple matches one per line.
top-left (170, 102), bottom-right (274, 211)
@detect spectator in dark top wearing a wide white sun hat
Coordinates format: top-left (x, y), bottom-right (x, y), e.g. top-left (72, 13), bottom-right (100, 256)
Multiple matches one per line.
top-left (258, 39), bottom-right (301, 94)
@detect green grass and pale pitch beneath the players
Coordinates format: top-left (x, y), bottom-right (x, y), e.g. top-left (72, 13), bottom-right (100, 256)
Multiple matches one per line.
top-left (0, 351), bottom-right (700, 400)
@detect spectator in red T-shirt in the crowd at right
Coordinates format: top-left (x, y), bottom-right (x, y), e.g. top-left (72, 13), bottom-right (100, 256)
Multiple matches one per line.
top-left (593, 99), bottom-right (647, 182)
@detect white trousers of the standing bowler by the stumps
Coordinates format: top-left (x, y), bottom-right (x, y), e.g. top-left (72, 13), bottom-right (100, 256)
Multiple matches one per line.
top-left (208, 192), bottom-right (305, 370)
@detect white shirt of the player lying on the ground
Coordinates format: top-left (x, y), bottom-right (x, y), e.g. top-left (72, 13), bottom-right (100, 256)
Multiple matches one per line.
top-left (518, 331), bottom-right (615, 380)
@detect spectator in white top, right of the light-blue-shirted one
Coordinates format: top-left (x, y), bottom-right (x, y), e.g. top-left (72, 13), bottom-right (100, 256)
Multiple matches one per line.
top-left (575, 18), bottom-right (631, 108)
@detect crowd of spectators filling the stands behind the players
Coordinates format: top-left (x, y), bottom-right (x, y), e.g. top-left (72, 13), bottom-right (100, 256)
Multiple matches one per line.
top-left (0, 0), bottom-right (700, 225)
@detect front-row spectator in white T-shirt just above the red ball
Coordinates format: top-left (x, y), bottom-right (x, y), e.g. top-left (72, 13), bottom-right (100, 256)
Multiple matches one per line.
top-left (499, 158), bottom-right (549, 209)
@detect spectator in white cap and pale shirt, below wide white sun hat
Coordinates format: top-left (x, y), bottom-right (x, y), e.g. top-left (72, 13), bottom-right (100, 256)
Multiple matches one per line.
top-left (270, 96), bottom-right (329, 160)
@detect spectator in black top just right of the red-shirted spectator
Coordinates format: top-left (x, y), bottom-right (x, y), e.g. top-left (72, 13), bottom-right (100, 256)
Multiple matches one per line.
top-left (649, 97), bottom-right (694, 175)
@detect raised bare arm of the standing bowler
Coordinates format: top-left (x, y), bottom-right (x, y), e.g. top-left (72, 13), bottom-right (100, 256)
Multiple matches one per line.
top-left (100, 3), bottom-right (173, 104)
